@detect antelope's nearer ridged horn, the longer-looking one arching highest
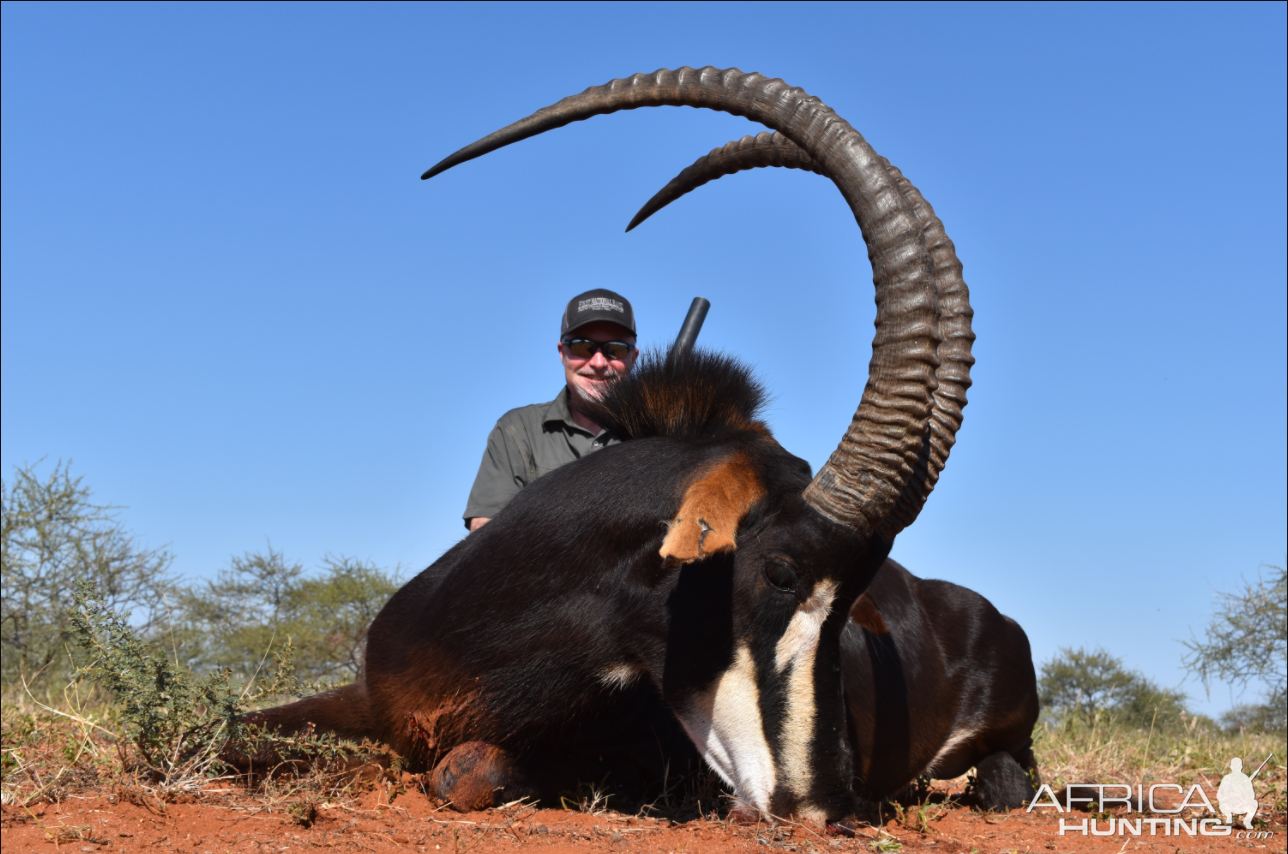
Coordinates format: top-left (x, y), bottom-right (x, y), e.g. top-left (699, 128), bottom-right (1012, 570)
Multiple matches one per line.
top-left (421, 67), bottom-right (940, 536)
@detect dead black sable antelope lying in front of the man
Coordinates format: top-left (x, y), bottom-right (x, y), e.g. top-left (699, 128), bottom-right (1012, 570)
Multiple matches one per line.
top-left (258, 68), bottom-right (1036, 821)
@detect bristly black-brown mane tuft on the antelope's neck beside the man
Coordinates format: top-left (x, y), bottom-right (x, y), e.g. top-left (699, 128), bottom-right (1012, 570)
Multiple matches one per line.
top-left (594, 349), bottom-right (768, 442)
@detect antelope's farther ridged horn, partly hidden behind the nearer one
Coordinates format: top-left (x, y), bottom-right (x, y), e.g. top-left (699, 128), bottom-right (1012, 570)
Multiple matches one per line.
top-left (626, 130), bottom-right (975, 536)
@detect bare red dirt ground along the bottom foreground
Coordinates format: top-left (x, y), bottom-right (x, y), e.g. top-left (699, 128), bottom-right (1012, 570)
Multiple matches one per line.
top-left (0, 790), bottom-right (1288, 854)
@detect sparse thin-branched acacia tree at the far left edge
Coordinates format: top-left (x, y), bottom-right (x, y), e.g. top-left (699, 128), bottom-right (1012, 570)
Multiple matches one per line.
top-left (0, 461), bottom-right (174, 690)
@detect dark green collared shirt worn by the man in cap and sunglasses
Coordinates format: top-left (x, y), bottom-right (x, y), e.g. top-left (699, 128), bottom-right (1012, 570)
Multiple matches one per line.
top-left (464, 386), bottom-right (621, 526)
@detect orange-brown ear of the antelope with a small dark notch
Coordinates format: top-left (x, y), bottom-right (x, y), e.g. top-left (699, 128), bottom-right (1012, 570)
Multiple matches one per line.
top-left (659, 452), bottom-right (765, 565)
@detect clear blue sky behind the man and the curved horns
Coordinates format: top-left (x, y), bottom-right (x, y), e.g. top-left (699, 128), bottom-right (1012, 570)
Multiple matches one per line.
top-left (0, 3), bottom-right (1288, 711)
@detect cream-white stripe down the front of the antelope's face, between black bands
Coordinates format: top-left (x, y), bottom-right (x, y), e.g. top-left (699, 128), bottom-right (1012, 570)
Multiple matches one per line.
top-left (775, 581), bottom-right (836, 799)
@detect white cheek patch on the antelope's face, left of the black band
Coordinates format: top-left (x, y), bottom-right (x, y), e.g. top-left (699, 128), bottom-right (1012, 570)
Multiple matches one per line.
top-left (679, 644), bottom-right (774, 810)
